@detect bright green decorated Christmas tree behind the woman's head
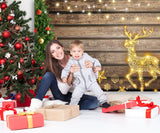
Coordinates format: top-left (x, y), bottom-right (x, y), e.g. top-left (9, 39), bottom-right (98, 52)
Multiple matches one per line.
top-left (34, 0), bottom-right (55, 61)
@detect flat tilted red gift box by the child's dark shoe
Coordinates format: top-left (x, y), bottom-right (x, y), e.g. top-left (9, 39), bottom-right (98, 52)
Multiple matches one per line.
top-left (102, 100), bottom-right (137, 113)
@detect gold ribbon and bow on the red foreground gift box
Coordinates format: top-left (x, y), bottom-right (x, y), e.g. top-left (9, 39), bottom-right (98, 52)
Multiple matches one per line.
top-left (18, 111), bottom-right (34, 128)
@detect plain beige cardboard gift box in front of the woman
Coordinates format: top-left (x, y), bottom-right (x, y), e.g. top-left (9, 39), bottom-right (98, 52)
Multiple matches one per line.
top-left (36, 105), bottom-right (79, 121)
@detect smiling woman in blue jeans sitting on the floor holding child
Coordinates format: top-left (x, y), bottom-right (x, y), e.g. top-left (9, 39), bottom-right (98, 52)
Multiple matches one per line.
top-left (29, 40), bottom-right (99, 110)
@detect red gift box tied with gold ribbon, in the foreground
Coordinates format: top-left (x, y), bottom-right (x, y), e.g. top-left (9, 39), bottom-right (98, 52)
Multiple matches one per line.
top-left (6, 112), bottom-right (44, 130)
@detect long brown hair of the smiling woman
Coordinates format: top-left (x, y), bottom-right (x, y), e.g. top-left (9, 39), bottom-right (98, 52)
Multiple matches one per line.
top-left (45, 40), bottom-right (63, 80)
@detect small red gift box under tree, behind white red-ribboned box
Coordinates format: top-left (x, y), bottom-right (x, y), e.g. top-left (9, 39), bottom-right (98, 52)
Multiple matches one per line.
top-left (2, 99), bottom-right (17, 108)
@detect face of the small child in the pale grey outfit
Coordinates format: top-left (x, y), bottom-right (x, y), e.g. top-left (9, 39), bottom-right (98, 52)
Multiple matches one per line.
top-left (70, 46), bottom-right (84, 60)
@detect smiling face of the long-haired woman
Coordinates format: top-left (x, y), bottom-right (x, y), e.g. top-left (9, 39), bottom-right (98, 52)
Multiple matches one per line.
top-left (50, 43), bottom-right (64, 60)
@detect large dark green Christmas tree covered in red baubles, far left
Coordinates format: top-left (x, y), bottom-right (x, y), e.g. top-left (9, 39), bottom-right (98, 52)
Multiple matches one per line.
top-left (0, 1), bottom-right (43, 103)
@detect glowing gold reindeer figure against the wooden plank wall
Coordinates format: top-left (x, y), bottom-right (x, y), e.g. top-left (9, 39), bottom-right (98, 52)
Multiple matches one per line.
top-left (124, 26), bottom-right (160, 91)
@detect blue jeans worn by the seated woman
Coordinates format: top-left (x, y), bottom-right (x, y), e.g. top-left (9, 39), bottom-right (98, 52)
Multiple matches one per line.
top-left (36, 72), bottom-right (99, 110)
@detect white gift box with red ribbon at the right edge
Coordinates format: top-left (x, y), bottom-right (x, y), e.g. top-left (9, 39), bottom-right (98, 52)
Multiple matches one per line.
top-left (125, 106), bottom-right (159, 118)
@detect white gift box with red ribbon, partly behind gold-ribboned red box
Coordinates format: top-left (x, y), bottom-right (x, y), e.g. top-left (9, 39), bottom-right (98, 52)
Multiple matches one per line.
top-left (0, 107), bottom-right (24, 121)
